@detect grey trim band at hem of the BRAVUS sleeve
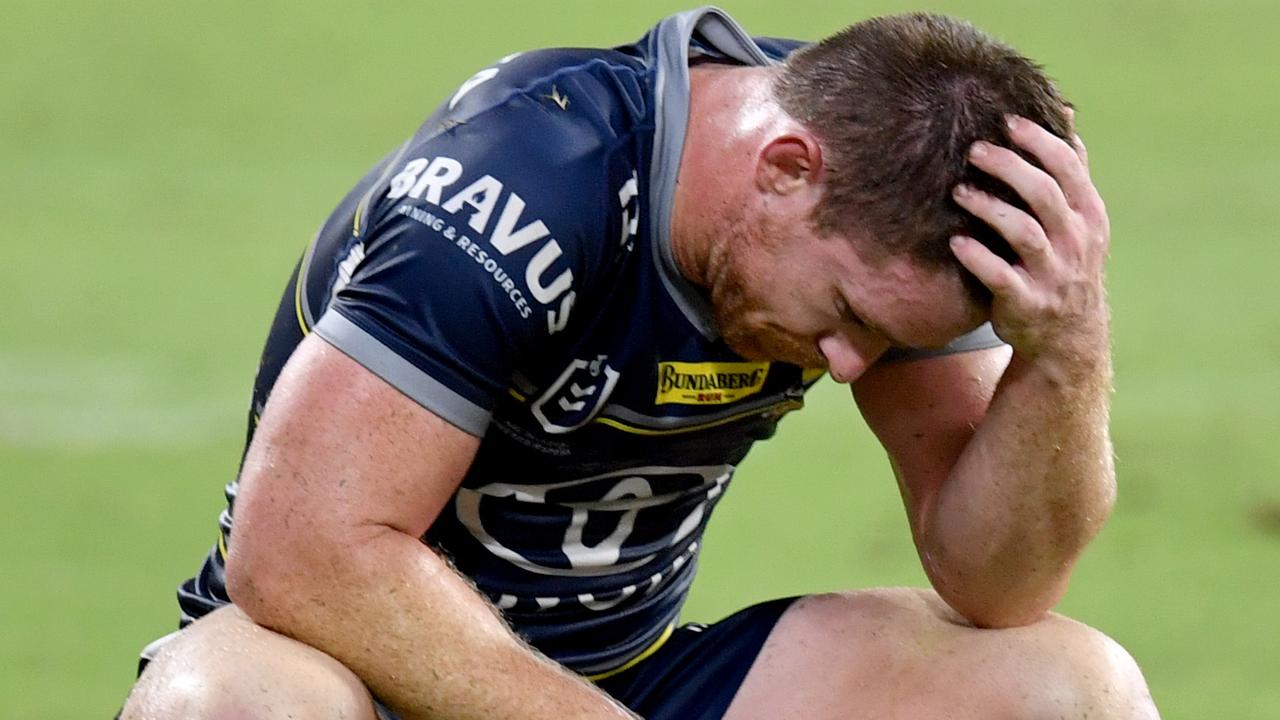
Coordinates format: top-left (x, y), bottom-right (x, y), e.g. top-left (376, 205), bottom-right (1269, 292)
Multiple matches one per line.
top-left (312, 309), bottom-right (492, 437)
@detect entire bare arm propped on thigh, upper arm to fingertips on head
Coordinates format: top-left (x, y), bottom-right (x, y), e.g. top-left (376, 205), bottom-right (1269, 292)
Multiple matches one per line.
top-left (854, 112), bottom-right (1115, 626)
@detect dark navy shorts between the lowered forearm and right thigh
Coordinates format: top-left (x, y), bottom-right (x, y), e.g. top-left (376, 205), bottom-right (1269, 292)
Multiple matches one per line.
top-left (375, 597), bottom-right (796, 720)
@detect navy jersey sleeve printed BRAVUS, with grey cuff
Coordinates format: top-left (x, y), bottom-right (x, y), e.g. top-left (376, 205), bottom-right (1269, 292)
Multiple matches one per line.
top-left (315, 53), bottom-right (632, 436)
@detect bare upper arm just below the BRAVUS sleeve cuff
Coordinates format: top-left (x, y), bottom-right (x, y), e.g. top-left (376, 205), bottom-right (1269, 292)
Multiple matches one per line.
top-left (229, 334), bottom-right (480, 569)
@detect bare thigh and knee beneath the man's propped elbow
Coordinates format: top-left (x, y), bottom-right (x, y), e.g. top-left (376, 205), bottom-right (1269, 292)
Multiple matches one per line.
top-left (726, 588), bottom-right (1155, 720)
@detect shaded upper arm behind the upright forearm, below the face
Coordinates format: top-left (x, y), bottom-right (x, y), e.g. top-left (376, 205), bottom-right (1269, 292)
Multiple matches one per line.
top-left (852, 346), bottom-right (1010, 528)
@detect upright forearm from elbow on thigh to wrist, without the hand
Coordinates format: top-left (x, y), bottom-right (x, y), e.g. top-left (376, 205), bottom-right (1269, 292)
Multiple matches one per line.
top-left (919, 343), bottom-right (1115, 625)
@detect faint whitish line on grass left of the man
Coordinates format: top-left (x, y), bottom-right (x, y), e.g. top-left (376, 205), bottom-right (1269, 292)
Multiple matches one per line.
top-left (0, 351), bottom-right (244, 450)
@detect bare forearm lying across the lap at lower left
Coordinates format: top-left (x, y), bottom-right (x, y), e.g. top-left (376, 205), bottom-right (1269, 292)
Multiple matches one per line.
top-left (232, 527), bottom-right (634, 720)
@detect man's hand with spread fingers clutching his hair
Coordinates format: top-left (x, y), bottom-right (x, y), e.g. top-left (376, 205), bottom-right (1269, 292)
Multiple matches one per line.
top-left (951, 117), bottom-right (1111, 380)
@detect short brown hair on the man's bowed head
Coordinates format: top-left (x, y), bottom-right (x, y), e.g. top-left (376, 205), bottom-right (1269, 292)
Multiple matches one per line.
top-left (774, 13), bottom-right (1071, 297)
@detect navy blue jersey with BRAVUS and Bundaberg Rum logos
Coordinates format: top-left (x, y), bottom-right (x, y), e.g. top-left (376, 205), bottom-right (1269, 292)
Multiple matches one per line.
top-left (179, 9), bottom-right (996, 674)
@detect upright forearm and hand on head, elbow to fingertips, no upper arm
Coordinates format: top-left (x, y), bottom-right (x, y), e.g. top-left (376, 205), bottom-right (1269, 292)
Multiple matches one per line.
top-left (916, 110), bottom-right (1115, 625)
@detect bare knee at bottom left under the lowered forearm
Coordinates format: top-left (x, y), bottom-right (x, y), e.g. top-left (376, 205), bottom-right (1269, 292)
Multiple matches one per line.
top-left (120, 606), bottom-right (376, 720)
